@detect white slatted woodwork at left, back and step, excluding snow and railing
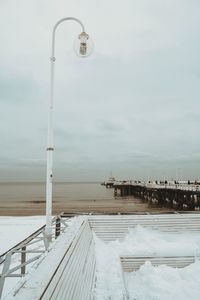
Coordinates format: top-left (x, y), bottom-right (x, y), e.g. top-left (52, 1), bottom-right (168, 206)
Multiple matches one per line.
top-left (4, 213), bottom-right (200, 300)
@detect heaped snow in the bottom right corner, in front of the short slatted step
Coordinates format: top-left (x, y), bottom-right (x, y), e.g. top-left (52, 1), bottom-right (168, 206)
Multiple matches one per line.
top-left (125, 261), bottom-right (200, 300)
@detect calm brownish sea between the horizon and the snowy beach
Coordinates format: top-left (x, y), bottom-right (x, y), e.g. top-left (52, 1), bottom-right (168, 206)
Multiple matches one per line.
top-left (0, 183), bottom-right (173, 216)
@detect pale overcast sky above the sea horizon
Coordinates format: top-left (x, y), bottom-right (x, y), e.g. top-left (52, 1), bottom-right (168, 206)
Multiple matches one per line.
top-left (0, 0), bottom-right (200, 181)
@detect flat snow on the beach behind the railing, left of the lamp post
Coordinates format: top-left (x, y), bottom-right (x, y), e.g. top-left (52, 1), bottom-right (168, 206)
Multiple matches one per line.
top-left (0, 216), bottom-right (45, 255)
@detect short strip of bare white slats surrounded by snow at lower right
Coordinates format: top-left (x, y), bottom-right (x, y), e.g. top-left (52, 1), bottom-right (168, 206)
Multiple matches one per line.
top-left (120, 255), bottom-right (195, 272)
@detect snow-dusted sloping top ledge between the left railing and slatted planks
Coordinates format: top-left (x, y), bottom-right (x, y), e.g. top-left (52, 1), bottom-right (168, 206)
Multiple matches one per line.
top-left (3, 217), bottom-right (84, 300)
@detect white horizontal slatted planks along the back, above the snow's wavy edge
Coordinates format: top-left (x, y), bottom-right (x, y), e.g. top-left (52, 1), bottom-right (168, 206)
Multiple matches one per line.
top-left (88, 214), bottom-right (200, 241)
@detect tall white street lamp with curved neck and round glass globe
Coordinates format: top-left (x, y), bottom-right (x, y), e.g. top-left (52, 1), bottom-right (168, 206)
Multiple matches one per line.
top-left (45, 17), bottom-right (92, 245)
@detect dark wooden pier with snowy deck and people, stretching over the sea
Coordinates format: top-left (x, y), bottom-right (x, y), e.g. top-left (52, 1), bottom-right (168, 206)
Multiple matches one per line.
top-left (113, 181), bottom-right (200, 211)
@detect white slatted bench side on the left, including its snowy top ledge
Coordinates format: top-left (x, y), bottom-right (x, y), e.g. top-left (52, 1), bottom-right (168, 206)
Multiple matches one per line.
top-left (2, 216), bottom-right (96, 300)
